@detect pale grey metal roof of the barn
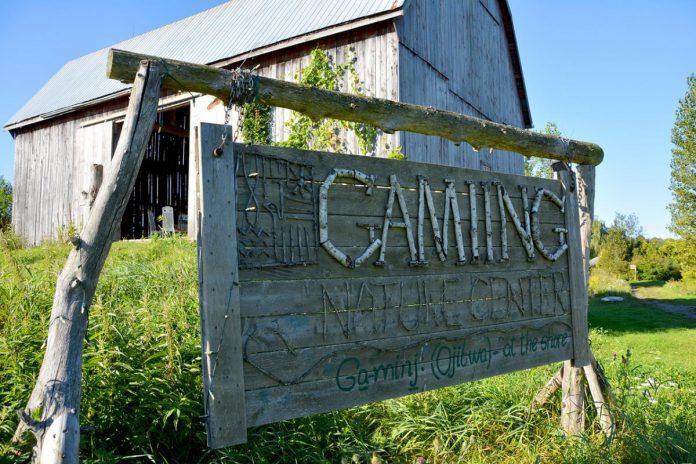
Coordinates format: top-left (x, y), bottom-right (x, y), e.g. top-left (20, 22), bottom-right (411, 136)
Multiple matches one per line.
top-left (5, 0), bottom-right (405, 127)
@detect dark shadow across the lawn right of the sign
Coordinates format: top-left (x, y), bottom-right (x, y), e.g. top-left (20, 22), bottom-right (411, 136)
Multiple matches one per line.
top-left (588, 295), bottom-right (696, 333)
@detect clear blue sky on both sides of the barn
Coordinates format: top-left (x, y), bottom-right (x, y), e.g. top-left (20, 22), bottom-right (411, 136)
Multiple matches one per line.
top-left (0, 0), bottom-right (696, 237)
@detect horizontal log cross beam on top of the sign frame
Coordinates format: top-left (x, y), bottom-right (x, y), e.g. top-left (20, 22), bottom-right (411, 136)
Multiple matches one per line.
top-left (106, 49), bottom-right (604, 165)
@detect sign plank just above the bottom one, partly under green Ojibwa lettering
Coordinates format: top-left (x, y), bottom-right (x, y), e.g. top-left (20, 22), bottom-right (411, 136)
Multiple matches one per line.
top-left (245, 315), bottom-right (572, 393)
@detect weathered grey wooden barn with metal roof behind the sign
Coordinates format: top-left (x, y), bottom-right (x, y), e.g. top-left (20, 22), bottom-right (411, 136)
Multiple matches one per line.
top-left (5, 0), bottom-right (531, 244)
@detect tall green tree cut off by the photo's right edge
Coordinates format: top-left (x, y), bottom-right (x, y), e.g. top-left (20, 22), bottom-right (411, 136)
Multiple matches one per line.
top-left (669, 74), bottom-right (696, 278)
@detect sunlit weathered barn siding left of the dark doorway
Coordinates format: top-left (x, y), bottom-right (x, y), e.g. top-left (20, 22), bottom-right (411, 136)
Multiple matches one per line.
top-left (12, 99), bottom-right (127, 245)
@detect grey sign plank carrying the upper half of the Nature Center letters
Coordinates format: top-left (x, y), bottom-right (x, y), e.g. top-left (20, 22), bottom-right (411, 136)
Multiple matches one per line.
top-left (240, 268), bottom-right (570, 317)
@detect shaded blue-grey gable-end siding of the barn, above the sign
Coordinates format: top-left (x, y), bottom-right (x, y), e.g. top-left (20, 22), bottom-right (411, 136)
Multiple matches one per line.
top-left (396, 0), bottom-right (524, 174)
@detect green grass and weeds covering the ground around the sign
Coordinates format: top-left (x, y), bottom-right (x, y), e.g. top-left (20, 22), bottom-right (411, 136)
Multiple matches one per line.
top-left (0, 238), bottom-right (696, 463)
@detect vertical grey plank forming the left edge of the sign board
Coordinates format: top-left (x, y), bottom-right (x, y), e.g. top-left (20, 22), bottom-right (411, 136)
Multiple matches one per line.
top-left (198, 124), bottom-right (246, 448)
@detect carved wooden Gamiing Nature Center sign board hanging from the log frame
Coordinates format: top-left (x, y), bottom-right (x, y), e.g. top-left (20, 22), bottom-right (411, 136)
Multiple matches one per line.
top-left (199, 125), bottom-right (587, 447)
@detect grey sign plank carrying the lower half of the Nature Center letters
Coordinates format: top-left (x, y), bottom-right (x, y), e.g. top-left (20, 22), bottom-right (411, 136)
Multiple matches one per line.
top-left (244, 292), bottom-right (570, 355)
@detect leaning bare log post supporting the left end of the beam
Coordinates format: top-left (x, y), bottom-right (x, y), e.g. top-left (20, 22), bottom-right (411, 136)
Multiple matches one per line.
top-left (14, 62), bottom-right (162, 464)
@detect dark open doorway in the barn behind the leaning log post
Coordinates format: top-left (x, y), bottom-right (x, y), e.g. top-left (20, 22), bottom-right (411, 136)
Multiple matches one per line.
top-left (114, 105), bottom-right (190, 239)
